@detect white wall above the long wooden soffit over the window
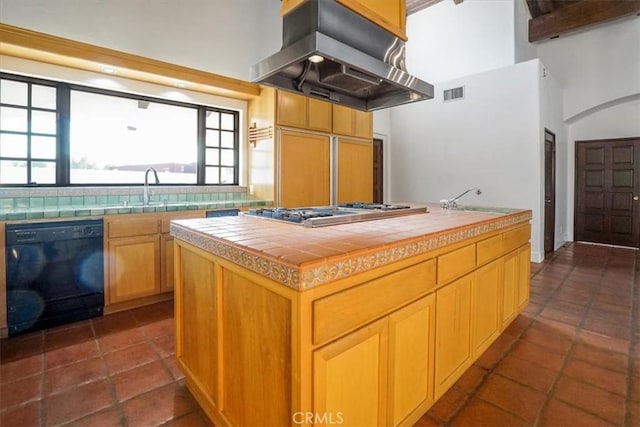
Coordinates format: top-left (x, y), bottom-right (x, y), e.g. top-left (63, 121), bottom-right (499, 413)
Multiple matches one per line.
top-left (0, 0), bottom-right (282, 80)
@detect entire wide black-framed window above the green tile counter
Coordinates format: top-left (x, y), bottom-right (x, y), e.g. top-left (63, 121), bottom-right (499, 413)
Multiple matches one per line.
top-left (0, 74), bottom-right (240, 185)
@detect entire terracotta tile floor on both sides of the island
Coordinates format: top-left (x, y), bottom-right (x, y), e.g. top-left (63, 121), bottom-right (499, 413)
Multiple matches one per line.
top-left (0, 244), bottom-right (640, 427)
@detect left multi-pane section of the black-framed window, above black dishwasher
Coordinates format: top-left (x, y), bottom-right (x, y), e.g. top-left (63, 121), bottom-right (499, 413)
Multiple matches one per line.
top-left (0, 79), bottom-right (58, 184)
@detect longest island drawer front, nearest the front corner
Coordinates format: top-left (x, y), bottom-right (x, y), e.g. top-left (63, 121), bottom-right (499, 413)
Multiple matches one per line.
top-left (313, 260), bottom-right (436, 344)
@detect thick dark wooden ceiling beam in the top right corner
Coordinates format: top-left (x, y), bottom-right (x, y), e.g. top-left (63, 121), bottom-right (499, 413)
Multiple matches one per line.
top-left (529, 0), bottom-right (640, 43)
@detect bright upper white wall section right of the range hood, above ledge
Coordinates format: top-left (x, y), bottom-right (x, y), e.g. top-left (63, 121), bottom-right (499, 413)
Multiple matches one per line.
top-left (406, 0), bottom-right (523, 83)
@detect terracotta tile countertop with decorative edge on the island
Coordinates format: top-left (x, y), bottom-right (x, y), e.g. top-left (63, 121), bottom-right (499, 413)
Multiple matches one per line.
top-left (170, 204), bottom-right (531, 290)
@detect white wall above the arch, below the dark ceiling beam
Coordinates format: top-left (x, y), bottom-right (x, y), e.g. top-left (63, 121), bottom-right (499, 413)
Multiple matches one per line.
top-left (538, 16), bottom-right (640, 120)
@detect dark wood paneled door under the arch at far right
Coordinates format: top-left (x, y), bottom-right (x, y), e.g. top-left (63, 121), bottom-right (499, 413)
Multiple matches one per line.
top-left (575, 138), bottom-right (640, 247)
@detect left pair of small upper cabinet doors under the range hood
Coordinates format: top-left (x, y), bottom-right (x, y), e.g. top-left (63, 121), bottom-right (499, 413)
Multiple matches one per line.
top-left (276, 90), bottom-right (331, 132)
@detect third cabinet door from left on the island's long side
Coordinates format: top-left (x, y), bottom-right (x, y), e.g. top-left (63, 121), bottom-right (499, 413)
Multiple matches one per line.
top-left (434, 274), bottom-right (473, 399)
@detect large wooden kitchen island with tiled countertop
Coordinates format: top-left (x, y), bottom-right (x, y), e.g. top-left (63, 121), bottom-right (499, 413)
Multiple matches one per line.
top-left (171, 205), bottom-right (531, 426)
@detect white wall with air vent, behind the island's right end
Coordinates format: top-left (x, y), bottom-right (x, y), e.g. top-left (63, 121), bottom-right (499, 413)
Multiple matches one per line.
top-left (391, 60), bottom-right (544, 260)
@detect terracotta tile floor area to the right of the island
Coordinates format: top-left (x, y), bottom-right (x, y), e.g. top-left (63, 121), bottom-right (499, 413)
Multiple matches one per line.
top-left (416, 244), bottom-right (640, 427)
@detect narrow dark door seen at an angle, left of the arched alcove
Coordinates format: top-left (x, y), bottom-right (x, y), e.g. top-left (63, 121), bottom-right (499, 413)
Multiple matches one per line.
top-left (544, 129), bottom-right (556, 255)
